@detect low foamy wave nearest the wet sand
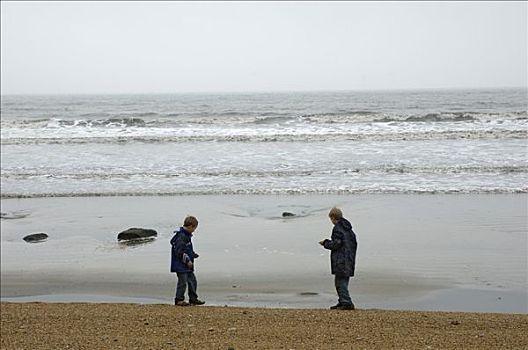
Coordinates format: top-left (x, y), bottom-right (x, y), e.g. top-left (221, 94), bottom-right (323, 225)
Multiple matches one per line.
top-left (1, 165), bottom-right (528, 198)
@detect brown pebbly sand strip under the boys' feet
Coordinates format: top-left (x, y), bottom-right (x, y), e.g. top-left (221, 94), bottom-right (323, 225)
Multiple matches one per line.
top-left (1, 303), bottom-right (528, 350)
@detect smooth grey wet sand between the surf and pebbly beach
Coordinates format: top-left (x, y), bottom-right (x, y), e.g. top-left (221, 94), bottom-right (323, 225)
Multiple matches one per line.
top-left (0, 194), bottom-right (528, 313)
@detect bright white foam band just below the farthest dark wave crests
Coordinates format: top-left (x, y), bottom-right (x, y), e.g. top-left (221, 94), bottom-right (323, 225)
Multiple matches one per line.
top-left (1, 119), bottom-right (528, 145)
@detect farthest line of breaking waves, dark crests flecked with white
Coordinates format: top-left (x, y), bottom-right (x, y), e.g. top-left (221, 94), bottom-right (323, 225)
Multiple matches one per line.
top-left (1, 111), bottom-right (528, 128)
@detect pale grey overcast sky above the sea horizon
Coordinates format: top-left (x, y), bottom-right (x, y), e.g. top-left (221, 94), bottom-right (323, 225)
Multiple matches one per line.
top-left (0, 1), bottom-right (528, 94)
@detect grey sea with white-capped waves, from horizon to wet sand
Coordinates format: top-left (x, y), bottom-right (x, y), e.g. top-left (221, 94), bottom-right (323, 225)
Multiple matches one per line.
top-left (1, 88), bottom-right (528, 198)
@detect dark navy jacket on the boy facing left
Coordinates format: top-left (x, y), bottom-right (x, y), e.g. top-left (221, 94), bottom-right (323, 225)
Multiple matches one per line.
top-left (323, 218), bottom-right (357, 276)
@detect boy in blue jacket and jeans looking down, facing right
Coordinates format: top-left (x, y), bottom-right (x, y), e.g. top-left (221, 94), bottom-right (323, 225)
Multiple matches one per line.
top-left (170, 216), bottom-right (205, 306)
